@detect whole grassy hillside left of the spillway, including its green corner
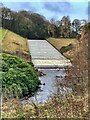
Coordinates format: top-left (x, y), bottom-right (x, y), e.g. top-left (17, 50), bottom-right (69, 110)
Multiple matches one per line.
top-left (0, 29), bottom-right (31, 61)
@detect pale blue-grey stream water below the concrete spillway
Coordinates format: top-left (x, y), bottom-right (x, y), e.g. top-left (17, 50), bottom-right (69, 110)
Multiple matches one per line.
top-left (22, 69), bottom-right (71, 104)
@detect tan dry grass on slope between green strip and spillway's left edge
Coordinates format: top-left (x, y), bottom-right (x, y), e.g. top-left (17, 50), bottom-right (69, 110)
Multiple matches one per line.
top-left (2, 31), bottom-right (29, 53)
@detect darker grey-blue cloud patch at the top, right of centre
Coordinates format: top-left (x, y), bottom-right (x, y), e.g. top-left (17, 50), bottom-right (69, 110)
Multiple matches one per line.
top-left (44, 2), bottom-right (72, 13)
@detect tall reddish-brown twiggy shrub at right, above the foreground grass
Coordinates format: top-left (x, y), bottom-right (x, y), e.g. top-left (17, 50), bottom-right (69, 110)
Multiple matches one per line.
top-left (67, 24), bottom-right (90, 96)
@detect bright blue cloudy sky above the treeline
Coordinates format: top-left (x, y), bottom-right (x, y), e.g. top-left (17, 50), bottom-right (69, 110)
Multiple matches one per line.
top-left (2, 0), bottom-right (88, 20)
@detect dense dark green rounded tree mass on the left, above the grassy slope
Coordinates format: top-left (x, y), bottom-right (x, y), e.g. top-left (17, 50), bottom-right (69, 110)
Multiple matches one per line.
top-left (2, 8), bottom-right (47, 39)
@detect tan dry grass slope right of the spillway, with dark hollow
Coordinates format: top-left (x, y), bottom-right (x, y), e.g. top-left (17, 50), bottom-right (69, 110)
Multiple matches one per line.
top-left (48, 38), bottom-right (79, 60)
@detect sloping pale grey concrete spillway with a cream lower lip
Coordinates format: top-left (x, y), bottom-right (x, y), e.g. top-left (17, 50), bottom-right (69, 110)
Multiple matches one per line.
top-left (28, 40), bottom-right (71, 68)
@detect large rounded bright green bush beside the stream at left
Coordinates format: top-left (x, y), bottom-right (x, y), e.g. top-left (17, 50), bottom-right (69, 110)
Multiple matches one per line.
top-left (0, 54), bottom-right (40, 99)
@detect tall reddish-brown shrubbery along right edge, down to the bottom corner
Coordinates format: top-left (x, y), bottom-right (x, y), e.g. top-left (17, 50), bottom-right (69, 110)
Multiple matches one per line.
top-left (61, 23), bottom-right (90, 119)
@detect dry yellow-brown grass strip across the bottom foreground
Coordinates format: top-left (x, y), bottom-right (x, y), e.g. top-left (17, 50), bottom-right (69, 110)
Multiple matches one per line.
top-left (2, 95), bottom-right (88, 119)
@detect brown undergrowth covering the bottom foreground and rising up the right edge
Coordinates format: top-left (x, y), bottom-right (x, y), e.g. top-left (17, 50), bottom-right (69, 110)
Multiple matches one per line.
top-left (2, 25), bottom-right (90, 120)
